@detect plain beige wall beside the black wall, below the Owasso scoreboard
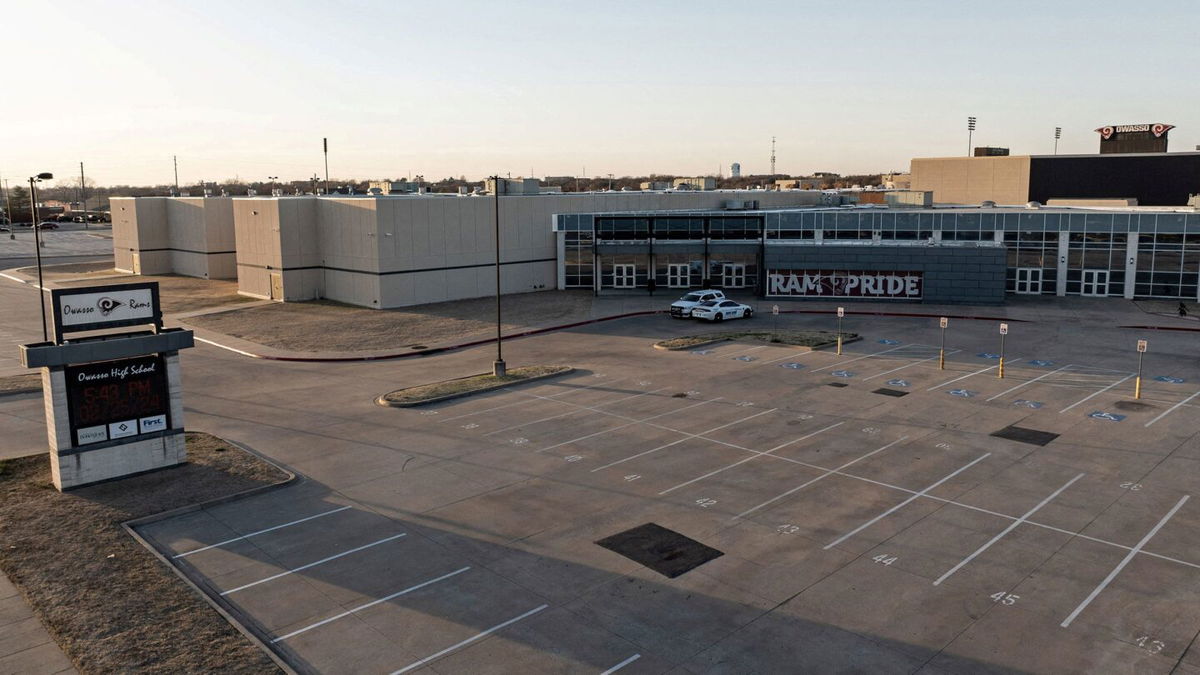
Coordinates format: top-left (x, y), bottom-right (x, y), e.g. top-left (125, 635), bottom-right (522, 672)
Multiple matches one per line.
top-left (912, 155), bottom-right (1030, 204)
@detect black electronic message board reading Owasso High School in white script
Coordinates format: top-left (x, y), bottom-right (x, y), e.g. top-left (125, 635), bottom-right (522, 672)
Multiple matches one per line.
top-left (64, 354), bottom-right (170, 446)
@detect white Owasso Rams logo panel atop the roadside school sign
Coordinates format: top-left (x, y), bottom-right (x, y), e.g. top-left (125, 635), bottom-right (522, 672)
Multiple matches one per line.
top-left (50, 281), bottom-right (162, 342)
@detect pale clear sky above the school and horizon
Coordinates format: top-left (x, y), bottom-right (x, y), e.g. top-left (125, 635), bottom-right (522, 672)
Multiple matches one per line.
top-left (0, 0), bottom-right (1200, 185)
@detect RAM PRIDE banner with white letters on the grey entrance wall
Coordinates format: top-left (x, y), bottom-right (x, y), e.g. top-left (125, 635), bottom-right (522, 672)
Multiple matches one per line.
top-left (767, 269), bottom-right (922, 300)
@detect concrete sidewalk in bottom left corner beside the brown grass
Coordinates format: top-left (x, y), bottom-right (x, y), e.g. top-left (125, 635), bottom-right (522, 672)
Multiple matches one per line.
top-left (0, 574), bottom-right (77, 675)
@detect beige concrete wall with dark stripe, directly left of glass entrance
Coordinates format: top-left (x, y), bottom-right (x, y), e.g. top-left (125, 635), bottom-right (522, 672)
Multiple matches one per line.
top-left (241, 186), bottom-right (820, 307)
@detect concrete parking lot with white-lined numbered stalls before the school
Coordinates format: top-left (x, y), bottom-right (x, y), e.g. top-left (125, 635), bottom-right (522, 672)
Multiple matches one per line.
top-left (131, 312), bottom-right (1200, 673)
